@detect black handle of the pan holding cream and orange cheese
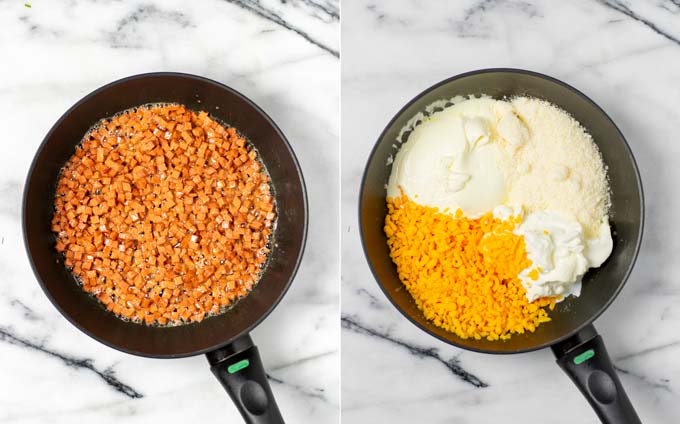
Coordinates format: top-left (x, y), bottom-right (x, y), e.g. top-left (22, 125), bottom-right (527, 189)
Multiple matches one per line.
top-left (552, 324), bottom-right (641, 424)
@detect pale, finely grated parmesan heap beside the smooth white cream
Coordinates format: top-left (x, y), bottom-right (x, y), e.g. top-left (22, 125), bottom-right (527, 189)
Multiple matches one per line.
top-left (504, 97), bottom-right (610, 237)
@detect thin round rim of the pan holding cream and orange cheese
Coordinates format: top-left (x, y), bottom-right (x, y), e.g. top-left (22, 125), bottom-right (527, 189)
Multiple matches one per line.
top-left (357, 67), bottom-right (645, 355)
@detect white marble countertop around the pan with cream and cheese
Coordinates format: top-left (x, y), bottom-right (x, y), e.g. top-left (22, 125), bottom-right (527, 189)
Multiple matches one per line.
top-left (341, 0), bottom-right (680, 424)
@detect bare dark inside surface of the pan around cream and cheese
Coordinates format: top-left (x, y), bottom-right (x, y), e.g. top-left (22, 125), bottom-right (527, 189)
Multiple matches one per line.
top-left (359, 70), bottom-right (643, 353)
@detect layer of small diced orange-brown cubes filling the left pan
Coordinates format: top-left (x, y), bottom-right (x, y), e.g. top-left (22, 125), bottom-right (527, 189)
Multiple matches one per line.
top-left (52, 105), bottom-right (276, 325)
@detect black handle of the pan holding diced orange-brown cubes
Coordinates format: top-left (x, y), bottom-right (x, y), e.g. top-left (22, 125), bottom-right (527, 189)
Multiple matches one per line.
top-left (206, 334), bottom-right (284, 424)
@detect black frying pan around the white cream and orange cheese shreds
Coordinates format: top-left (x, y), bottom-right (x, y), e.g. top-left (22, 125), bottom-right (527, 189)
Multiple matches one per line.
top-left (359, 69), bottom-right (644, 423)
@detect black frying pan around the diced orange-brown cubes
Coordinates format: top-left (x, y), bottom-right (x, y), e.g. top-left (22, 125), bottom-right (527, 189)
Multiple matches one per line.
top-left (22, 73), bottom-right (307, 423)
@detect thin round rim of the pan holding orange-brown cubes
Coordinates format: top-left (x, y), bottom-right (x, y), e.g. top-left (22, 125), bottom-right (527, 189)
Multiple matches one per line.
top-left (21, 71), bottom-right (309, 359)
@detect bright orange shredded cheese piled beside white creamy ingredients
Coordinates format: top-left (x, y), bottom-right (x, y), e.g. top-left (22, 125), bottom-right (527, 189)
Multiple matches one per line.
top-left (385, 195), bottom-right (555, 341)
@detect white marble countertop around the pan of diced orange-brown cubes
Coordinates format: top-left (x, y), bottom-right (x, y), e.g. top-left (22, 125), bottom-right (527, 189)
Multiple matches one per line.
top-left (0, 0), bottom-right (340, 424)
